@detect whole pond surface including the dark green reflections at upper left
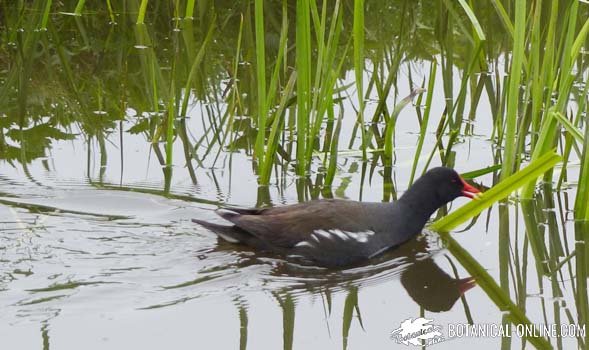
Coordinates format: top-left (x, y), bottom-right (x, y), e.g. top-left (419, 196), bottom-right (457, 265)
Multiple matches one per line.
top-left (0, 2), bottom-right (586, 349)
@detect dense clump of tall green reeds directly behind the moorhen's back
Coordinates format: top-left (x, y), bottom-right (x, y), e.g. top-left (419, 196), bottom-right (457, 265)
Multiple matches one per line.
top-left (243, 1), bottom-right (344, 185)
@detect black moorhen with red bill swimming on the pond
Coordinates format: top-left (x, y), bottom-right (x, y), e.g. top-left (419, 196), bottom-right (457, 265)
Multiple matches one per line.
top-left (192, 167), bottom-right (479, 267)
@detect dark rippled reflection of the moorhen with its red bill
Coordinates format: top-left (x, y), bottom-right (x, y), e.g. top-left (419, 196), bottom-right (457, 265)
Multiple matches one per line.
top-left (217, 231), bottom-right (475, 312)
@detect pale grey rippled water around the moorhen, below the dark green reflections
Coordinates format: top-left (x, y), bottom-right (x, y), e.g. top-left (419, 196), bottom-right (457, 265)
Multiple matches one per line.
top-left (0, 3), bottom-right (583, 349)
